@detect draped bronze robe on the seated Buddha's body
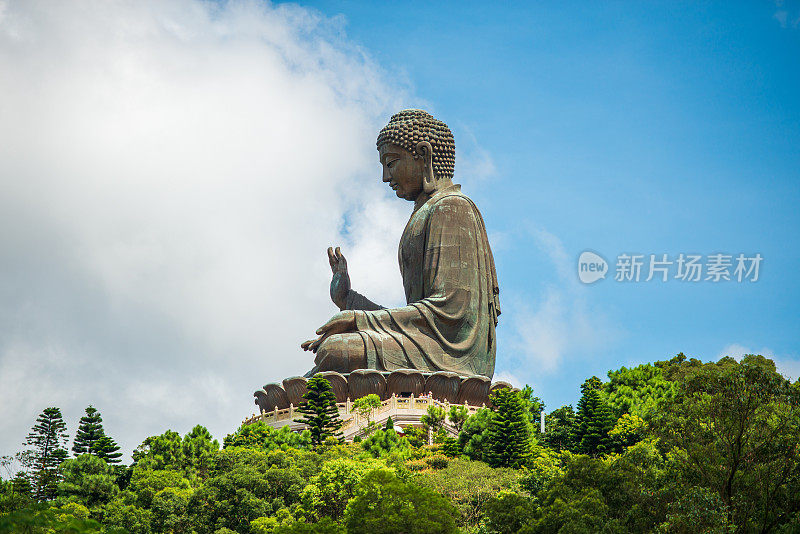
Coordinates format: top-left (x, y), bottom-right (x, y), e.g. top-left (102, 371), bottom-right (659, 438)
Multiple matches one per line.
top-left (347, 185), bottom-right (500, 378)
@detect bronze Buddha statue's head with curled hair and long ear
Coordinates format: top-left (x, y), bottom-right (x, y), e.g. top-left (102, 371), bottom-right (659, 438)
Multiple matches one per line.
top-left (377, 109), bottom-right (456, 201)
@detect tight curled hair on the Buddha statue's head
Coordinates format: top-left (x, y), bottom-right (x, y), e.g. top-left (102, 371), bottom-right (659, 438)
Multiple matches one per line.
top-left (376, 109), bottom-right (456, 178)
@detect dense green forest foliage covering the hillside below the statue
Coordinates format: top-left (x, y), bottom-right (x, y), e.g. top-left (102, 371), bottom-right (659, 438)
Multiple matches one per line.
top-left (0, 354), bottom-right (800, 534)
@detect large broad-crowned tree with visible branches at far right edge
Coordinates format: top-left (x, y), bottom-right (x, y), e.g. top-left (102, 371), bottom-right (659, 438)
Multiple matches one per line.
top-left (652, 355), bottom-right (800, 532)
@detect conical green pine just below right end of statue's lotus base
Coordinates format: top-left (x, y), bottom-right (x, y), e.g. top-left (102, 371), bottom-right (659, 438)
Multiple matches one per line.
top-left (485, 388), bottom-right (532, 467)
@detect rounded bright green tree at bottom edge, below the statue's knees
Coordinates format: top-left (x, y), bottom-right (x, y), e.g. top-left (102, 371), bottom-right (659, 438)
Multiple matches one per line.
top-left (345, 469), bottom-right (458, 534)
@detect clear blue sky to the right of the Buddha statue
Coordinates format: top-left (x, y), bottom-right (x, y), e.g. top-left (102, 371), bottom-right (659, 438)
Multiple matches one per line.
top-left (294, 2), bottom-right (800, 408)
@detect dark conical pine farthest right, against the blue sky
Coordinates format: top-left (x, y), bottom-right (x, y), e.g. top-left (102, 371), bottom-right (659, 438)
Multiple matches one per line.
top-left (575, 376), bottom-right (614, 456)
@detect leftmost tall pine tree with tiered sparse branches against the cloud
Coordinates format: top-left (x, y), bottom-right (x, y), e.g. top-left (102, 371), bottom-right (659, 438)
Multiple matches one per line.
top-left (25, 407), bottom-right (69, 501)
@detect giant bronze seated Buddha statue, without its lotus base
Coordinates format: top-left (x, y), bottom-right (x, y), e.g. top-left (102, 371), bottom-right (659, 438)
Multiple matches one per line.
top-left (301, 109), bottom-right (500, 379)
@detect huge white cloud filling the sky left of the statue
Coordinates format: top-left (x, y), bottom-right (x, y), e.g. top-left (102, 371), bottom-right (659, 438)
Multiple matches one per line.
top-left (0, 0), bottom-right (422, 460)
